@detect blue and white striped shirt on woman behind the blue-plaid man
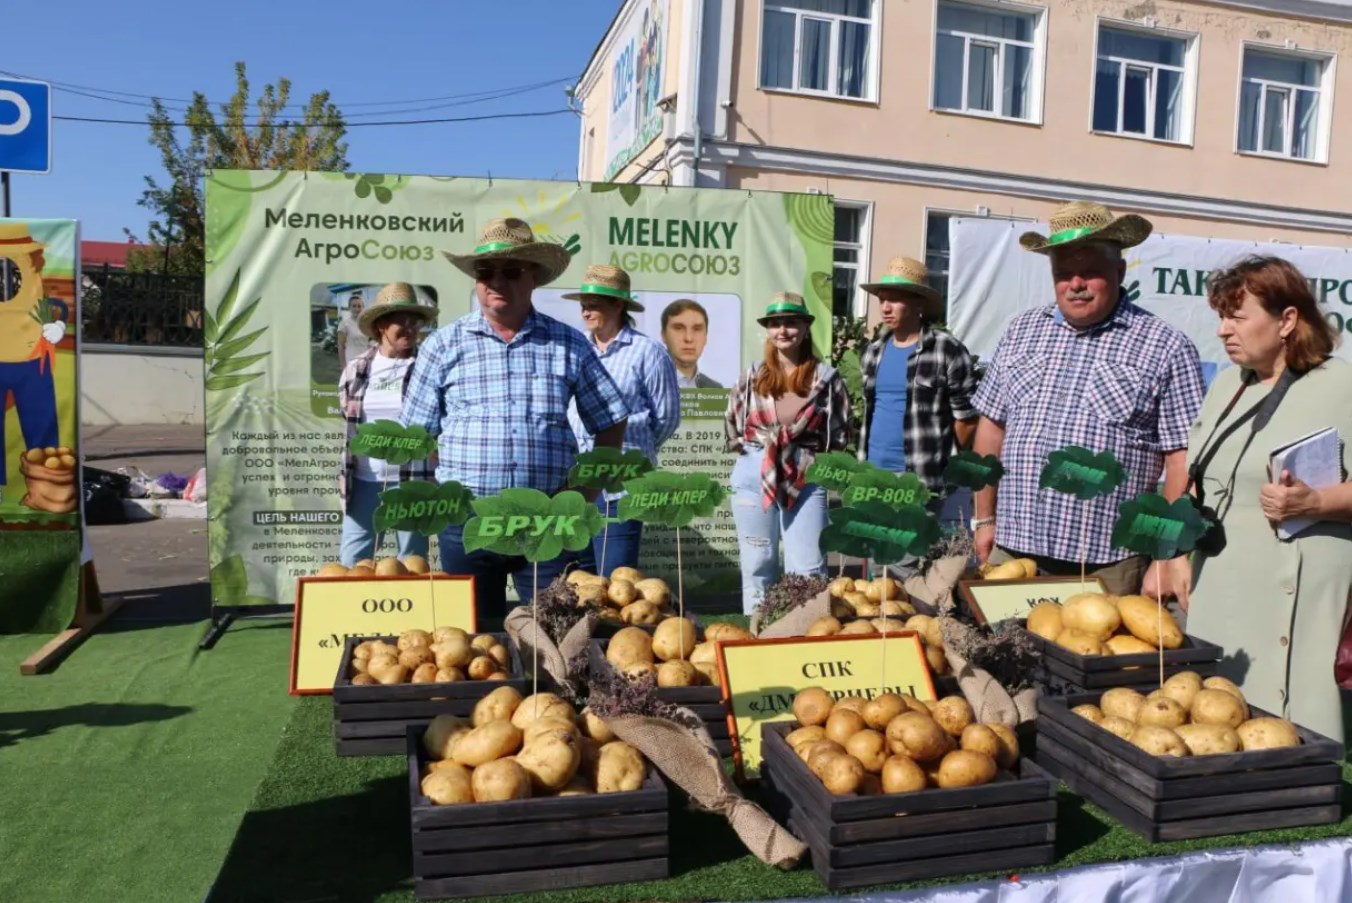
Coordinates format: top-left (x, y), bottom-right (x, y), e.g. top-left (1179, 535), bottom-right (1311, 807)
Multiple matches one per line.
top-left (568, 326), bottom-right (680, 486)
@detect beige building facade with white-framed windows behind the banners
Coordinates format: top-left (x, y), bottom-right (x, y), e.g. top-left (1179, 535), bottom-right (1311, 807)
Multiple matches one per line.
top-left (575, 0), bottom-right (1352, 315)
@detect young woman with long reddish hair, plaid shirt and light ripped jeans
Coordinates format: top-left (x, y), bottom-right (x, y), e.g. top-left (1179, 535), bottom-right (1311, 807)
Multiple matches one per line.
top-left (723, 292), bottom-right (850, 614)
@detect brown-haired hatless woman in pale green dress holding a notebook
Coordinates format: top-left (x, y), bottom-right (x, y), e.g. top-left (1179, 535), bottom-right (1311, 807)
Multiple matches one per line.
top-left (1169, 257), bottom-right (1352, 739)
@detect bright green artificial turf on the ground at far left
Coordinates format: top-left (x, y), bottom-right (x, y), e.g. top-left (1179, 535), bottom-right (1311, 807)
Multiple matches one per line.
top-left (0, 622), bottom-right (295, 903)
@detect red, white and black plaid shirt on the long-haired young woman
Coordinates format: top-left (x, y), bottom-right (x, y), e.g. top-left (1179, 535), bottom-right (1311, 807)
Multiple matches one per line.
top-left (723, 362), bottom-right (850, 510)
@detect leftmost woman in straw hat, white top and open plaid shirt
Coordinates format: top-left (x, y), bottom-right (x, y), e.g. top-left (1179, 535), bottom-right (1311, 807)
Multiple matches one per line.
top-left (338, 283), bottom-right (437, 568)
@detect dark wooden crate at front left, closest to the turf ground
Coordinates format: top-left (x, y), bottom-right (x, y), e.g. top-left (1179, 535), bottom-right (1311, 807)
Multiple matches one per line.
top-left (404, 727), bottom-right (669, 900)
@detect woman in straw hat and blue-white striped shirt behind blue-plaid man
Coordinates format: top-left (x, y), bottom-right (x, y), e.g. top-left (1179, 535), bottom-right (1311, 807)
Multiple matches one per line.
top-left (564, 264), bottom-right (680, 575)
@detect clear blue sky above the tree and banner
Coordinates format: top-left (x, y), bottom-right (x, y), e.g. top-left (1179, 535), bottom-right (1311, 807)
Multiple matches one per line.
top-left (0, 0), bottom-right (618, 241)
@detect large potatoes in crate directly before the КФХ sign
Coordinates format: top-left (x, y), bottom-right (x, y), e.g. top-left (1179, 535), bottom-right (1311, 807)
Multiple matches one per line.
top-left (1028, 592), bottom-right (1183, 656)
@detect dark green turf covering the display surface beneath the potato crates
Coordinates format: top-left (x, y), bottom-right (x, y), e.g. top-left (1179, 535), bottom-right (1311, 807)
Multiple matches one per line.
top-left (212, 698), bottom-right (1352, 903)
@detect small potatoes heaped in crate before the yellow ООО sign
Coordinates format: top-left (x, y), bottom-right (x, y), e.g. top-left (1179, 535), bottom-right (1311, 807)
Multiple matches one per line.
top-left (352, 627), bottom-right (511, 687)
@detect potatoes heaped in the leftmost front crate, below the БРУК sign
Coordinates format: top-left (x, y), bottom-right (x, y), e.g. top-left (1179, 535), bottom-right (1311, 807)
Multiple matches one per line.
top-left (422, 687), bottom-right (648, 806)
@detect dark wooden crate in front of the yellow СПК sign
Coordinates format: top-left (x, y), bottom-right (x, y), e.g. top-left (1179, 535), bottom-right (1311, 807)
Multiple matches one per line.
top-left (760, 722), bottom-right (1056, 891)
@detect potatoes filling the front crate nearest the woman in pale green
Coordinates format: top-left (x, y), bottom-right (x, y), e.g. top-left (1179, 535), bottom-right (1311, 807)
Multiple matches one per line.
top-left (1071, 670), bottom-right (1301, 756)
